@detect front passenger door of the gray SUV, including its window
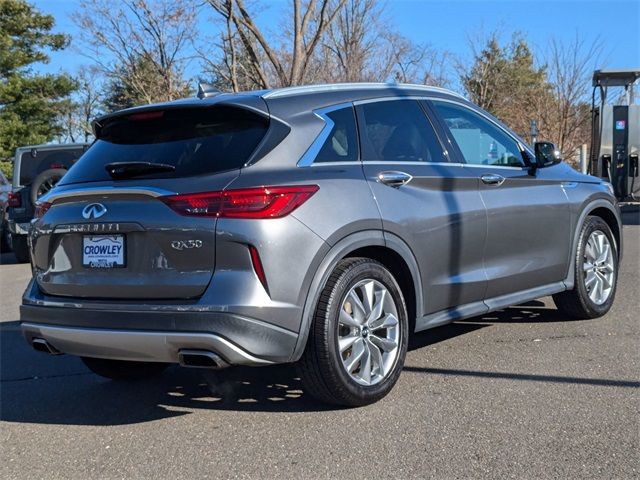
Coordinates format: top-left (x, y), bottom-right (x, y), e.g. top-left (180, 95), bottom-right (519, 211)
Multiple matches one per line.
top-left (432, 100), bottom-right (571, 299)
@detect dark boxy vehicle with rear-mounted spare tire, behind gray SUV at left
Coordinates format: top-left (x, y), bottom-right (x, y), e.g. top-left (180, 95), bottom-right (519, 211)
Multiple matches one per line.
top-left (7, 143), bottom-right (89, 263)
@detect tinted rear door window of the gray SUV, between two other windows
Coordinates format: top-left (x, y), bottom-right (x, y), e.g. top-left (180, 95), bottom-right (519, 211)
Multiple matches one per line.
top-left (362, 100), bottom-right (447, 162)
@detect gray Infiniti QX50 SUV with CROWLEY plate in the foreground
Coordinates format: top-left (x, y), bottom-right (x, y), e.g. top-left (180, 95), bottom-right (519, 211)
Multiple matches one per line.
top-left (21, 84), bottom-right (622, 405)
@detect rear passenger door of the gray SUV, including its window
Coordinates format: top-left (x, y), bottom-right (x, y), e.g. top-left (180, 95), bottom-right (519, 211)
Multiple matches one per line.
top-left (357, 99), bottom-right (487, 320)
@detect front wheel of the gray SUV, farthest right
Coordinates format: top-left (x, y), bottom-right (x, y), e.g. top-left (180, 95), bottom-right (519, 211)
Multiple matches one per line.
top-left (553, 217), bottom-right (618, 320)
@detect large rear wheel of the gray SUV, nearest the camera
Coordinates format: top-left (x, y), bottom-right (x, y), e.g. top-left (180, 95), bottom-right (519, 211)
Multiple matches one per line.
top-left (298, 258), bottom-right (408, 406)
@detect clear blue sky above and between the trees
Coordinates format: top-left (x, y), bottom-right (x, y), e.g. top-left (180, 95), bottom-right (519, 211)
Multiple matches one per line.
top-left (31, 0), bottom-right (640, 87)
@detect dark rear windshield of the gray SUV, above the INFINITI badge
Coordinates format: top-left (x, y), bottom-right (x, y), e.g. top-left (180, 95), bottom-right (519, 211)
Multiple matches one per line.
top-left (61, 106), bottom-right (269, 184)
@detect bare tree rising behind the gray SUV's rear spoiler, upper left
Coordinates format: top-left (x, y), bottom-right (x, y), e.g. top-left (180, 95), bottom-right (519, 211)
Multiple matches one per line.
top-left (73, 0), bottom-right (196, 103)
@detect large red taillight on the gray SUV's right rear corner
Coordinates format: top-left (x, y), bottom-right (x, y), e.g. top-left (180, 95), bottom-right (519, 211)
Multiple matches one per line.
top-left (160, 185), bottom-right (319, 218)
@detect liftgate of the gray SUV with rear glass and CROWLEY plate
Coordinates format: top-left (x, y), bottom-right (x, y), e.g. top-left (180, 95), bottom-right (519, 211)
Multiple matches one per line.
top-left (32, 106), bottom-right (268, 299)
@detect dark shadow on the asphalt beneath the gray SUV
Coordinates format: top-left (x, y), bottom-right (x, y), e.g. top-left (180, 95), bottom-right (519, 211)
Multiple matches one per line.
top-left (0, 302), bottom-right (616, 425)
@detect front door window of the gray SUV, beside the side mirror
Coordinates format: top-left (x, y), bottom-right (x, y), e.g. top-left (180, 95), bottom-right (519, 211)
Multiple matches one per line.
top-left (434, 102), bottom-right (524, 167)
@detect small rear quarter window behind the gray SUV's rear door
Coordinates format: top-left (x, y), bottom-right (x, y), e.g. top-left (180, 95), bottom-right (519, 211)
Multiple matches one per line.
top-left (314, 107), bottom-right (358, 163)
